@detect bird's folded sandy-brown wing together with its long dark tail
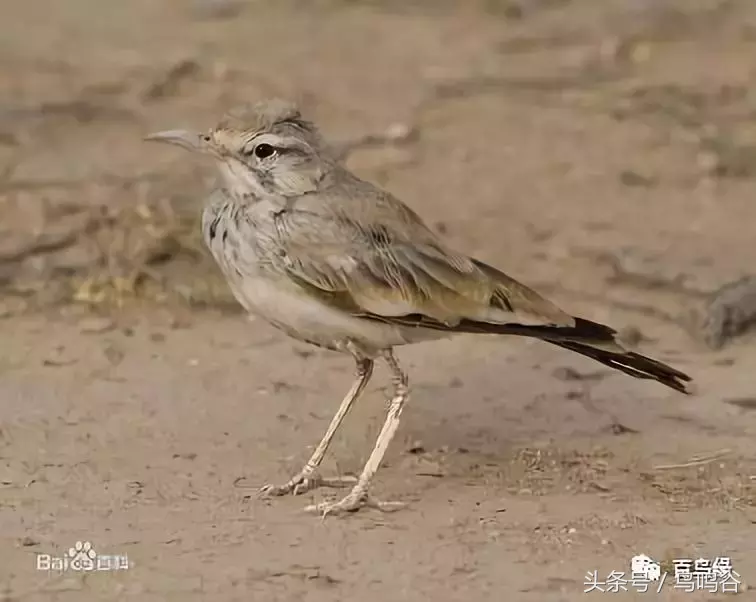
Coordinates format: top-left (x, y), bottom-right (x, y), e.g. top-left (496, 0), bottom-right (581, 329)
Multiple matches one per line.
top-left (258, 190), bottom-right (691, 393)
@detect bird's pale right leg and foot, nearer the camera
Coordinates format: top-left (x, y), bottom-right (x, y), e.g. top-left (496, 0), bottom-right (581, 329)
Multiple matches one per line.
top-left (305, 351), bottom-right (409, 517)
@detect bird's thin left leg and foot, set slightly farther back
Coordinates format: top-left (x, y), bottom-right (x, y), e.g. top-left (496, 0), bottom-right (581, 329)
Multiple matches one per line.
top-left (260, 356), bottom-right (375, 495)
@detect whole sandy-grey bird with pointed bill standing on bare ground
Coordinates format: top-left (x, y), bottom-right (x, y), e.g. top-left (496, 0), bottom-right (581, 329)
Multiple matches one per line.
top-left (146, 98), bottom-right (692, 517)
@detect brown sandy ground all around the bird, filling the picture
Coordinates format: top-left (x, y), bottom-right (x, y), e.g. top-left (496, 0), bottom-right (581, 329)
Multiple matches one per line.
top-left (0, 0), bottom-right (756, 602)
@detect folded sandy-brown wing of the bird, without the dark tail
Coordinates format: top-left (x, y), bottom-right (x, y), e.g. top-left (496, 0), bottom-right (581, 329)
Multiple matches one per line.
top-left (273, 206), bottom-right (574, 327)
